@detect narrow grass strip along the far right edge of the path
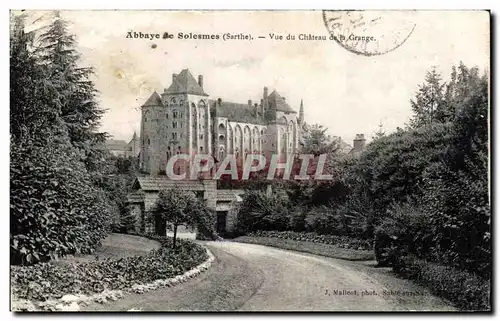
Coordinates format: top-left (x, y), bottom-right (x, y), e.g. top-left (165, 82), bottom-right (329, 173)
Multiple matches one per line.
top-left (232, 236), bottom-right (375, 261)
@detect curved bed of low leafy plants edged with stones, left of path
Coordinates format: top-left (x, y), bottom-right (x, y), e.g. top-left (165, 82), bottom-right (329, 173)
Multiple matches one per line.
top-left (11, 236), bottom-right (208, 301)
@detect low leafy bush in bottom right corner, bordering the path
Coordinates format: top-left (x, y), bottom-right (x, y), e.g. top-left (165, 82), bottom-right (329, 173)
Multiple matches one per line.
top-left (394, 256), bottom-right (491, 311)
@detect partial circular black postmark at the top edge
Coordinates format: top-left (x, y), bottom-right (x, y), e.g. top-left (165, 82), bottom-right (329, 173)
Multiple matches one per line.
top-left (323, 10), bottom-right (415, 56)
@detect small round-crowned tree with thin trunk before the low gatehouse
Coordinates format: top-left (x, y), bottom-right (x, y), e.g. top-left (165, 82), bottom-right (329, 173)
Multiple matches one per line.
top-left (146, 188), bottom-right (214, 248)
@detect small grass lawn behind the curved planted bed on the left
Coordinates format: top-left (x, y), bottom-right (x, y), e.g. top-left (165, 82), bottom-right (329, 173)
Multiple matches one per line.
top-left (53, 233), bottom-right (160, 264)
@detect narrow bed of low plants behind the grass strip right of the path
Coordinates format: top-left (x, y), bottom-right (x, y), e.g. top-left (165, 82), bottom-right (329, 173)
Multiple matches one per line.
top-left (248, 231), bottom-right (372, 250)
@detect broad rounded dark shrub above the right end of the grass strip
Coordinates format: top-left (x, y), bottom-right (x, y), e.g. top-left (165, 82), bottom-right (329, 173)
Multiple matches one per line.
top-left (351, 124), bottom-right (451, 226)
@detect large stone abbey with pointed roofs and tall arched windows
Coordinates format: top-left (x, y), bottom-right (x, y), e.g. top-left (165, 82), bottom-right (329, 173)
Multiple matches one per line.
top-left (139, 69), bottom-right (304, 175)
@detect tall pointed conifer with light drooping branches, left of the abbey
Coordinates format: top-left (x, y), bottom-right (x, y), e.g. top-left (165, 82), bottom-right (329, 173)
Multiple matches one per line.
top-left (38, 12), bottom-right (107, 175)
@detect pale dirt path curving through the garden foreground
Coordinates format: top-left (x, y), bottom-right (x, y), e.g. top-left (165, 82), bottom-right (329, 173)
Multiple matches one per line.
top-left (85, 242), bottom-right (455, 311)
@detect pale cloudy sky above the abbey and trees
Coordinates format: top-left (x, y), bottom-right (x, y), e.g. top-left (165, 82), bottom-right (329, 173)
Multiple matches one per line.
top-left (22, 11), bottom-right (490, 144)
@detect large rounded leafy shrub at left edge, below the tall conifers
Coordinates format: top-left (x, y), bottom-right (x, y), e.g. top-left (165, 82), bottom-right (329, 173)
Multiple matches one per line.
top-left (10, 141), bottom-right (110, 264)
